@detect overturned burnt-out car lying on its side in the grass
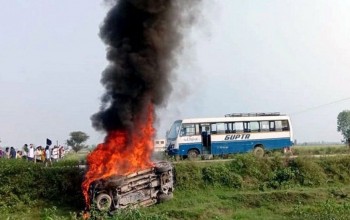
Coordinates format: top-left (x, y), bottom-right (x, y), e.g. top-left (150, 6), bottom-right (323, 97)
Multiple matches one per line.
top-left (89, 161), bottom-right (174, 211)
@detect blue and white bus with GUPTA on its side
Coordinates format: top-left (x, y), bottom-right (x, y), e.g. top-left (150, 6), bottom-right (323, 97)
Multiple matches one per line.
top-left (165, 112), bottom-right (293, 158)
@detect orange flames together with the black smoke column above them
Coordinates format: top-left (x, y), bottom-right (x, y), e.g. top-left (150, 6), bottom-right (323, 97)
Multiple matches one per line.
top-left (82, 0), bottom-right (200, 206)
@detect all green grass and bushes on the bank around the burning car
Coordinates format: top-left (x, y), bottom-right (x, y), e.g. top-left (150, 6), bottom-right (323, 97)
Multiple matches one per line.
top-left (0, 147), bottom-right (350, 220)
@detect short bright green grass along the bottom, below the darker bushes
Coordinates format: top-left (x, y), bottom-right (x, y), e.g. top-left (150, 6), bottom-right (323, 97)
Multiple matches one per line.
top-left (0, 186), bottom-right (350, 220)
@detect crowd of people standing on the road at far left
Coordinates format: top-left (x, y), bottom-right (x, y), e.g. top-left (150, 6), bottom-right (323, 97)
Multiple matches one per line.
top-left (0, 144), bottom-right (65, 166)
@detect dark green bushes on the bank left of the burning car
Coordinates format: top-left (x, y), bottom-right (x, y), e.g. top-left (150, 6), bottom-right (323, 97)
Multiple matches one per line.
top-left (0, 159), bottom-right (84, 210)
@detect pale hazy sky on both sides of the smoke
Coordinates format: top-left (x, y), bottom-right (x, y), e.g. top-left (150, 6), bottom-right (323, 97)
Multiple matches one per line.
top-left (0, 0), bottom-right (350, 148)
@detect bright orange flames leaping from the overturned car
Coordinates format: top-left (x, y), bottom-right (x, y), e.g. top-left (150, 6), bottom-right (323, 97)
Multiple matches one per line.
top-left (82, 105), bottom-right (155, 207)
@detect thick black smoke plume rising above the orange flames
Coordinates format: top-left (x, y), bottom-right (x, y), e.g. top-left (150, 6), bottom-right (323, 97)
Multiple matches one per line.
top-left (91, 0), bottom-right (200, 132)
